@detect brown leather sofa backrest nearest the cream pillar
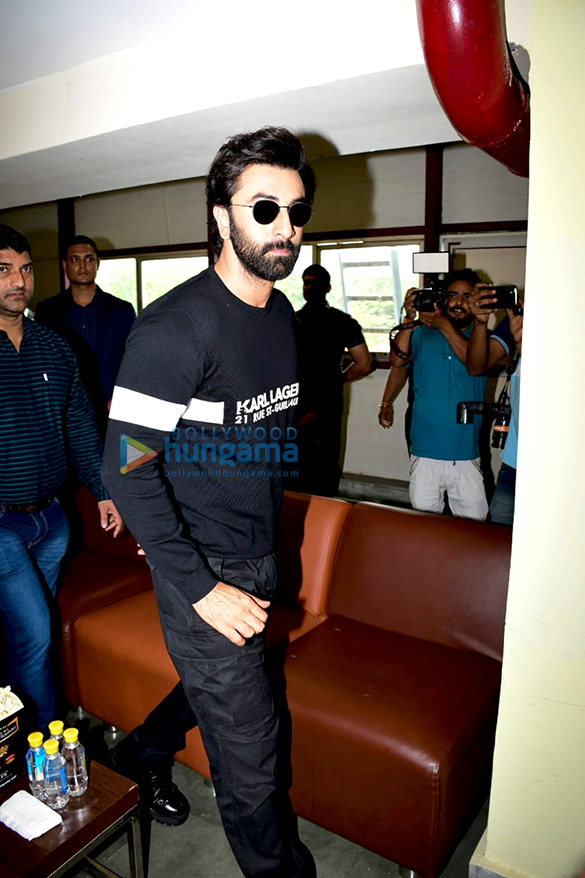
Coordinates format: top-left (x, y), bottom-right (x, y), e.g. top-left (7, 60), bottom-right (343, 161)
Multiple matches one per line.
top-left (327, 503), bottom-right (511, 661)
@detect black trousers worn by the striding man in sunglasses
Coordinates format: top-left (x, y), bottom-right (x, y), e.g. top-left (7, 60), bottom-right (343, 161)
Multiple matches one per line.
top-left (130, 555), bottom-right (314, 878)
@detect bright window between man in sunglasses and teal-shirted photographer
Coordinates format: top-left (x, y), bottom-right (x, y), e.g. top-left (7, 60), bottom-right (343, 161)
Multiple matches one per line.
top-left (318, 242), bottom-right (420, 352)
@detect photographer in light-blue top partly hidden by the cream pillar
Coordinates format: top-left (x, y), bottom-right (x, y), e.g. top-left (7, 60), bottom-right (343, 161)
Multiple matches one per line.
top-left (467, 287), bottom-right (524, 525)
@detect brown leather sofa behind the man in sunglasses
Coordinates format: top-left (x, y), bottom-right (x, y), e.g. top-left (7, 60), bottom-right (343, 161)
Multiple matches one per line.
top-left (60, 493), bottom-right (510, 878)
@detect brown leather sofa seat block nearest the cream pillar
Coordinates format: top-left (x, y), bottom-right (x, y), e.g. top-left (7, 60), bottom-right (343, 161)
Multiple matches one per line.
top-left (285, 616), bottom-right (500, 876)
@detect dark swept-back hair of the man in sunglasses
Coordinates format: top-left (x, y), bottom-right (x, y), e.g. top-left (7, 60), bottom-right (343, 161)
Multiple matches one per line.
top-left (205, 127), bottom-right (315, 253)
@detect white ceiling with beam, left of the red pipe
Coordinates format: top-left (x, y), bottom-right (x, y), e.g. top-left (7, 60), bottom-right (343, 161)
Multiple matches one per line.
top-left (0, 0), bottom-right (525, 208)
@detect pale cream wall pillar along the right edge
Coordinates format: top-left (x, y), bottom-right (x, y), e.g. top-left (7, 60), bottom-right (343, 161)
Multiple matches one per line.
top-left (468, 0), bottom-right (585, 878)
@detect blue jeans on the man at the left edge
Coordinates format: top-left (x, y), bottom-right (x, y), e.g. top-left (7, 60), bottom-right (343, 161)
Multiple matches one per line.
top-left (0, 500), bottom-right (69, 728)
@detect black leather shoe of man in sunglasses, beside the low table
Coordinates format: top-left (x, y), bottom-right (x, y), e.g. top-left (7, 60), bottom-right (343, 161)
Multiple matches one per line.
top-left (108, 741), bottom-right (190, 826)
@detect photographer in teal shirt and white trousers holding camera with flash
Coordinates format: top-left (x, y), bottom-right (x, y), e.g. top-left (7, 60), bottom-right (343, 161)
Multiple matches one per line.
top-left (378, 269), bottom-right (488, 521)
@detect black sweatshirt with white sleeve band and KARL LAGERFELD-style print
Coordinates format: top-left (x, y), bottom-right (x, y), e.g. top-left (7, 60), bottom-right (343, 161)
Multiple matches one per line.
top-left (102, 268), bottom-right (298, 603)
